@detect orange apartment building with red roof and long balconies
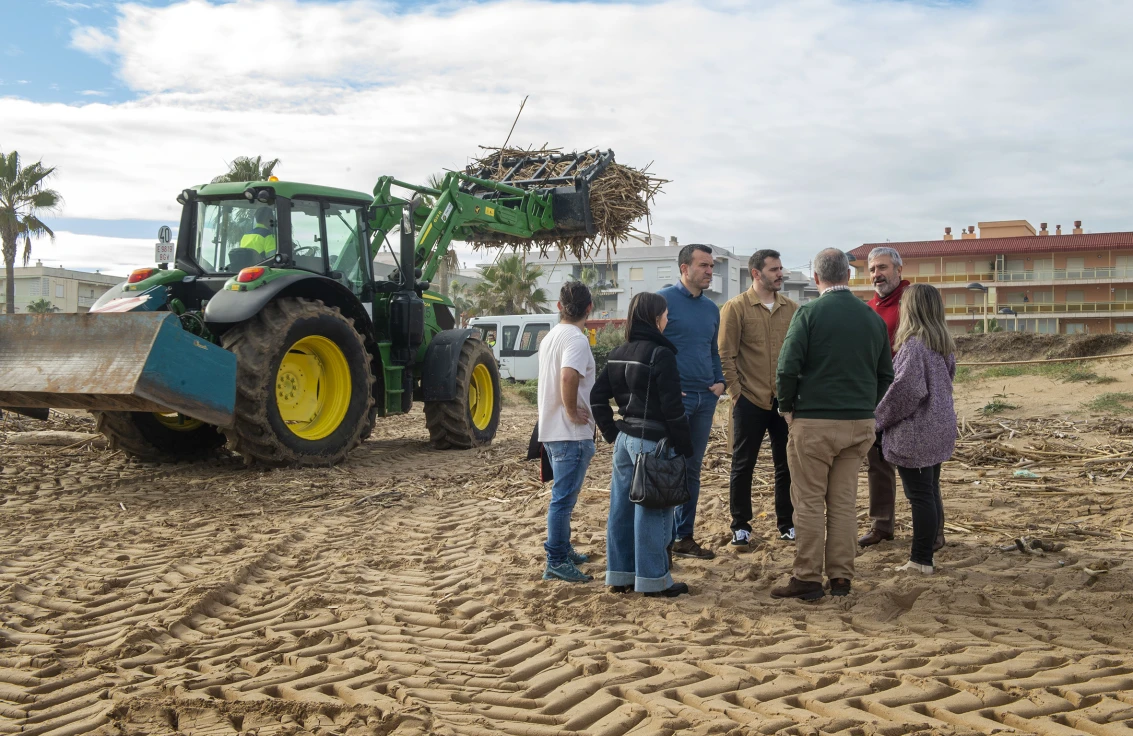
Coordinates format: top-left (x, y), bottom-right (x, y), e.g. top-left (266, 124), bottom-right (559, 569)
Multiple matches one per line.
top-left (850, 220), bottom-right (1133, 334)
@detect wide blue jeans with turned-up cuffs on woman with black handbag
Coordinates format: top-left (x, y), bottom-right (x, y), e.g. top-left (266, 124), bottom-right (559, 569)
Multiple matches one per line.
top-left (606, 434), bottom-right (673, 593)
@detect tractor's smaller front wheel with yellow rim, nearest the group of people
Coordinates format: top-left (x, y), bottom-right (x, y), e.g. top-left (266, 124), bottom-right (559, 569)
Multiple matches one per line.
top-left (425, 339), bottom-right (503, 450)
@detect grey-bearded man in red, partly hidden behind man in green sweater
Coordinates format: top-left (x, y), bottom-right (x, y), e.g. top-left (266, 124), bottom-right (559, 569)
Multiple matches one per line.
top-left (858, 247), bottom-right (909, 547)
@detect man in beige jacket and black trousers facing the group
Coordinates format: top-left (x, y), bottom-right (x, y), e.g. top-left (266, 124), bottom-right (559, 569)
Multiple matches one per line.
top-left (719, 249), bottom-right (799, 547)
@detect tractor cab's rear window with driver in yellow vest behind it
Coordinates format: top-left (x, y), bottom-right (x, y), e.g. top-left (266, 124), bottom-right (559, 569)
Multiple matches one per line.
top-left (194, 198), bottom-right (278, 273)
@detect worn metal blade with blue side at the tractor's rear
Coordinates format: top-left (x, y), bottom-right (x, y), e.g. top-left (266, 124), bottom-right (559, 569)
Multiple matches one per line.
top-left (0, 311), bottom-right (236, 427)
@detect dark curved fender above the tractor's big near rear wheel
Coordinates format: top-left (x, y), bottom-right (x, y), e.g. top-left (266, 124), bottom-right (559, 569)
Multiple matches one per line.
top-left (205, 274), bottom-right (374, 335)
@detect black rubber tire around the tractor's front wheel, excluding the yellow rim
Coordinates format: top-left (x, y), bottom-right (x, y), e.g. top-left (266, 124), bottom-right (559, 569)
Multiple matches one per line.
top-left (425, 337), bottom-right (503, 450)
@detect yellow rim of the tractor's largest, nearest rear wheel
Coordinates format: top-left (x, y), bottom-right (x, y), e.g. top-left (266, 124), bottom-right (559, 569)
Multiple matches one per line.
top-left (275, 335), bottom-right (351, 440)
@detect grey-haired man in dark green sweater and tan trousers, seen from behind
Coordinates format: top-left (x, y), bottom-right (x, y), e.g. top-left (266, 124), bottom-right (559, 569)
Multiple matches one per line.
top-left (772, 248), bottom-right (893, 600)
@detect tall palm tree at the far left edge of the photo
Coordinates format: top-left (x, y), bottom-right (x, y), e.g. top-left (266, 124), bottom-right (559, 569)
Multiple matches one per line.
top-left (0, 151), bottom-right (62, 315)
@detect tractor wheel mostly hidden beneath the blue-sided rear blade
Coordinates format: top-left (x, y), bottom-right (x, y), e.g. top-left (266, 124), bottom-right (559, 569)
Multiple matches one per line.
top-left (93, 411), bottom-right (224, 462)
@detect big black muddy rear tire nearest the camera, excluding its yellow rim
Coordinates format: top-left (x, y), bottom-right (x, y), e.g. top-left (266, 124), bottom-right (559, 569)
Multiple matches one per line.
top-left (221, 298), bottom-right (375, 467)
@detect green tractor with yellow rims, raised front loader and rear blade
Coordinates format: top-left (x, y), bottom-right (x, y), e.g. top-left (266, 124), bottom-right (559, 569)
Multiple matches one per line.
top-left (0, 152), bottom-right (613, 465)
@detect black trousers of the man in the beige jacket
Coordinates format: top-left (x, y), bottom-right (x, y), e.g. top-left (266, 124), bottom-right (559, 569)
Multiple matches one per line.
top-left (729, 396), bottom-right (794, 533)
